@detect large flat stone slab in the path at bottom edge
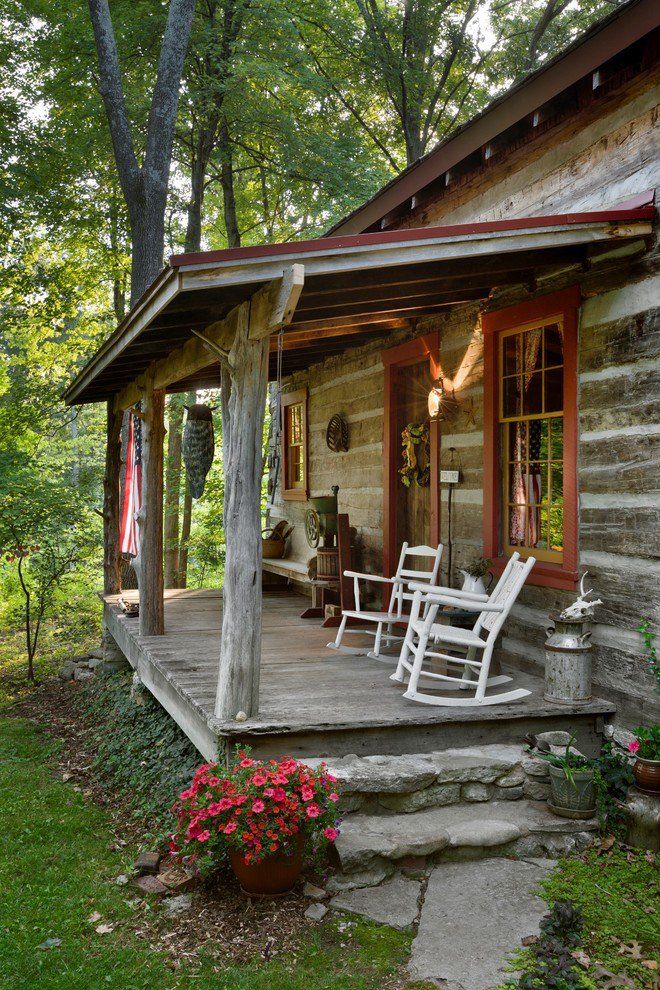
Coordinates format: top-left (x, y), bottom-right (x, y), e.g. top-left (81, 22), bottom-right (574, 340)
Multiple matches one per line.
top-left (409, 859), bottom-right (549, 990)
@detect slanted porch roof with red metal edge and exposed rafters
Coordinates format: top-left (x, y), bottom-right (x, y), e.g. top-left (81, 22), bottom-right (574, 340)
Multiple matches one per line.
top-left (64, 205), bottom-right (655, 405)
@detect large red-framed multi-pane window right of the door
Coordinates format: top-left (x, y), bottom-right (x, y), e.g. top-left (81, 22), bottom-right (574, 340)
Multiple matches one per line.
top-left (483, 287), bottom-right (580, 588)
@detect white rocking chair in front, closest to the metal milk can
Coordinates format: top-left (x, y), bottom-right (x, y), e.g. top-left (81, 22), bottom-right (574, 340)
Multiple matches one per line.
top-left (391, 553), bottom-right (536, 707)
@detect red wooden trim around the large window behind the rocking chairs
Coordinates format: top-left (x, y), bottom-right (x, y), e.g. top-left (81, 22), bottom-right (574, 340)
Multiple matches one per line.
top-left (482, 285), bottom-right (581, 590)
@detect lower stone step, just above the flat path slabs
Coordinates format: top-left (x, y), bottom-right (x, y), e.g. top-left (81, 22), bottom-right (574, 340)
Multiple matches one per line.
top-left (333, 799), bottom-right (598, 891)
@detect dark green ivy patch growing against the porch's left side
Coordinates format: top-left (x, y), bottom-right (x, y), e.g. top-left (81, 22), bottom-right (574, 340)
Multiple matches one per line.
top-left (81, 674), bottom-right (199, 834)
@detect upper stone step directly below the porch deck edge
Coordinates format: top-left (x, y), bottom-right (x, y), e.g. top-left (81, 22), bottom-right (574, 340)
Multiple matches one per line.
top-left (305, 744), bottom-right (565, 814)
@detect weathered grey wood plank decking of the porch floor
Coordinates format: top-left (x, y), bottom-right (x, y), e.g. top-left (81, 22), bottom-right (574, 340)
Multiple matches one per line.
top-left (105, 589), bottom-right (614, 758)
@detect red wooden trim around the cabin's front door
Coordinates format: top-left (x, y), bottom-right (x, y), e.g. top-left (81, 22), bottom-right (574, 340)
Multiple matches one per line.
top-left (381, 330), bottom-right (440, 577)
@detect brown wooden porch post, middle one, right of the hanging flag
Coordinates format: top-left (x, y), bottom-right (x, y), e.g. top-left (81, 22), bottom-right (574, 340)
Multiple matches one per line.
top-left (138, 378), bottom-right (165, 636)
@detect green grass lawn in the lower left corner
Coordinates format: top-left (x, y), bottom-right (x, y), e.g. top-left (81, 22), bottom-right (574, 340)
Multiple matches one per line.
top-left (0, 719), bottom-right (410, 990)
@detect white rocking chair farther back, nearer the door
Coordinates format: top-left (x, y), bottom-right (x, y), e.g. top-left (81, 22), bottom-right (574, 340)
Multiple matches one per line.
top-left (328, 543), bottom-right (443, 662)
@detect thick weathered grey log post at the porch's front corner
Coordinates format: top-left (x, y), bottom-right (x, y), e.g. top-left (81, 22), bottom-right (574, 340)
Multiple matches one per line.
top-left (215, 304), bottom-right (268, 721)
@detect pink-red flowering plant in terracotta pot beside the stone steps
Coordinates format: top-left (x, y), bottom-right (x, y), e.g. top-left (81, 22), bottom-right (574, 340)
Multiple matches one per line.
top-left (170, 750), bottom-right (339, 897)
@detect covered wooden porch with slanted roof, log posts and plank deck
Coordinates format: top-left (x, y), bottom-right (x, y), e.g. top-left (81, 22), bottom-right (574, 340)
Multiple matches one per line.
top-left (65, 204), bottom-right (653, 756)
